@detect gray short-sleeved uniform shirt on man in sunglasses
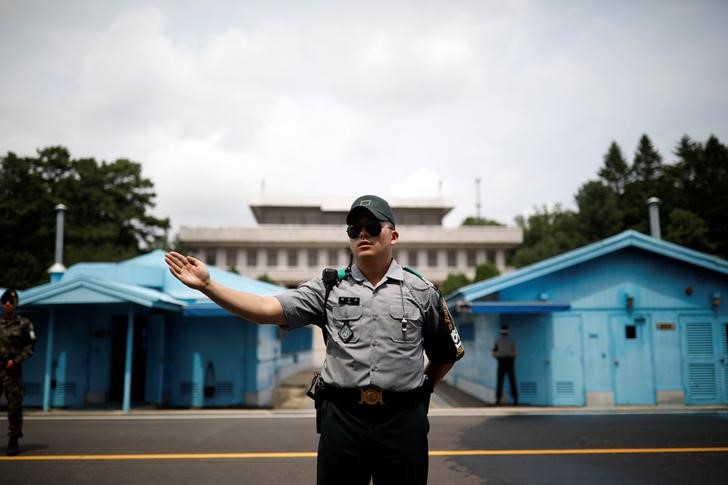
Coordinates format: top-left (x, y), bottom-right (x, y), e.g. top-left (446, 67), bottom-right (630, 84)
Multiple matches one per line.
top-left (276, 260), bottom-right (450, 391)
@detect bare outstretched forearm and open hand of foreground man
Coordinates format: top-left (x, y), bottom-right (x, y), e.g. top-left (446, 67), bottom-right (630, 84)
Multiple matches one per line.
top-left (164, 251), bottom-right (286, 325)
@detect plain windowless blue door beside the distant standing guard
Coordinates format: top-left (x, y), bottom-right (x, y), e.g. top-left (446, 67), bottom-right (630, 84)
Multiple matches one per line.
top-left (550, 315), bottom-right (585, 406)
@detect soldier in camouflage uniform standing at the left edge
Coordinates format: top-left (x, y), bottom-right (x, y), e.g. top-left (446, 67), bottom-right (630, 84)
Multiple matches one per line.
top-left (0, 289), bottom-right (35, 456)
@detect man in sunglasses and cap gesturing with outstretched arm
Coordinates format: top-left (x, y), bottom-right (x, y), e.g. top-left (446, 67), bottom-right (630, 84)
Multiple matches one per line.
top-left (165, 195), bottom-right (464, 485)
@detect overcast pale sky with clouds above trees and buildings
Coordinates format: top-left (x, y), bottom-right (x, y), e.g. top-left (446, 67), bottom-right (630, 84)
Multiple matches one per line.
top-left (0, 0), bottom-right (728, 234)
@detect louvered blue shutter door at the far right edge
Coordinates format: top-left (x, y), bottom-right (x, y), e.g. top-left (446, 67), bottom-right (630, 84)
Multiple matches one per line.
top-left (681, 314), bottom-right (728, 404)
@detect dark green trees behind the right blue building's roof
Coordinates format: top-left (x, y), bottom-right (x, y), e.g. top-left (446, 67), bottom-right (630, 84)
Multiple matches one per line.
top-left (512, 135), bottom-right (728, 267)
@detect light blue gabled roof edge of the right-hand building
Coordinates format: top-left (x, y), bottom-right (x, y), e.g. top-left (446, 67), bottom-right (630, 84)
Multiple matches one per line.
top-left (447, 230), bottom-right (728, 305)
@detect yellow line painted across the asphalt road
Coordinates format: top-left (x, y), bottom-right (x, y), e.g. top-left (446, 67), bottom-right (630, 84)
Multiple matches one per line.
top-left (0, 446), bottom-right (728, 461)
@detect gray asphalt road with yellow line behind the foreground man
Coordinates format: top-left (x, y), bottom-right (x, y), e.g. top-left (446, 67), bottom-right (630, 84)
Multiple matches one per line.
top-left (0, 407), bottom-right (728, 485)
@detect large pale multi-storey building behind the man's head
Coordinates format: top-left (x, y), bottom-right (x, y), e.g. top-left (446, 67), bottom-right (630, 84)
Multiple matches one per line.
top-left (179, 198), bottom-right (523, 287)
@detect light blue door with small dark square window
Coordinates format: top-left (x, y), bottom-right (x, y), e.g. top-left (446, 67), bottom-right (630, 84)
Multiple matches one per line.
top-left (609, 315), bottom-right (656, 404)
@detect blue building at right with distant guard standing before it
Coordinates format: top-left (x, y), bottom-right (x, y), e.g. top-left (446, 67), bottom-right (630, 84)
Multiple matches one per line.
top-left (448, 231), bottom-right (728, 406)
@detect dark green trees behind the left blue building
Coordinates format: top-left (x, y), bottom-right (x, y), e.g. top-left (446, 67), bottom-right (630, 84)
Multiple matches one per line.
top-left (0, 146), bottom-right (169, 288)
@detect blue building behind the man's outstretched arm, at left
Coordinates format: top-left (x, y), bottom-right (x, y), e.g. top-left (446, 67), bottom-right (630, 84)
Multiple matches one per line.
top-left (19, 251), bottom-right (312, 410)
